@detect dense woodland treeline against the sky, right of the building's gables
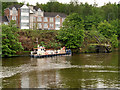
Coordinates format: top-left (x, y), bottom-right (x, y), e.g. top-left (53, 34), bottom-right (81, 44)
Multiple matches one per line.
top-left (36, 0), bottom-right (119, 21)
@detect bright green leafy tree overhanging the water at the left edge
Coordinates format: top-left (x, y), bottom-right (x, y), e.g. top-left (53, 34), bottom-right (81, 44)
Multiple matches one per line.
top-left (2, 25), bottom-right (23, 56)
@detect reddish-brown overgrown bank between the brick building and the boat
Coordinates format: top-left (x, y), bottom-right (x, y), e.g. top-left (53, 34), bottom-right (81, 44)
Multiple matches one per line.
top-left (18, 30), bottom-right (62, 51)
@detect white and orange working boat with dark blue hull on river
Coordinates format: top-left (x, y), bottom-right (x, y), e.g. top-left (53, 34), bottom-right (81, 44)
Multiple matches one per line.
top-left (31, 45), bottom-right (72, 58)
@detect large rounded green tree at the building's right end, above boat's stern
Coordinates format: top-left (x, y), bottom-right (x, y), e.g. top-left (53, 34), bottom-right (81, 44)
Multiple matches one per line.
top-left (58, 13), bottom-right (84, 49)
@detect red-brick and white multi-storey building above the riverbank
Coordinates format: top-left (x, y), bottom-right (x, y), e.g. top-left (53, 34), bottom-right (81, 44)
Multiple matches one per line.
top-left (4, 5), bottom-right (66, 30)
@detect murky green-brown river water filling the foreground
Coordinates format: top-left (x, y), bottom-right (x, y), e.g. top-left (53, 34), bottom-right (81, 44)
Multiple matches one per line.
top-left (0, 52), bottom-right (119, 88)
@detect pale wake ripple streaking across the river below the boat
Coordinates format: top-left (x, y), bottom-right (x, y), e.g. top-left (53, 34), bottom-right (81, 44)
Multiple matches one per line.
top-left (0, 60), bottom-right (118, 78)
